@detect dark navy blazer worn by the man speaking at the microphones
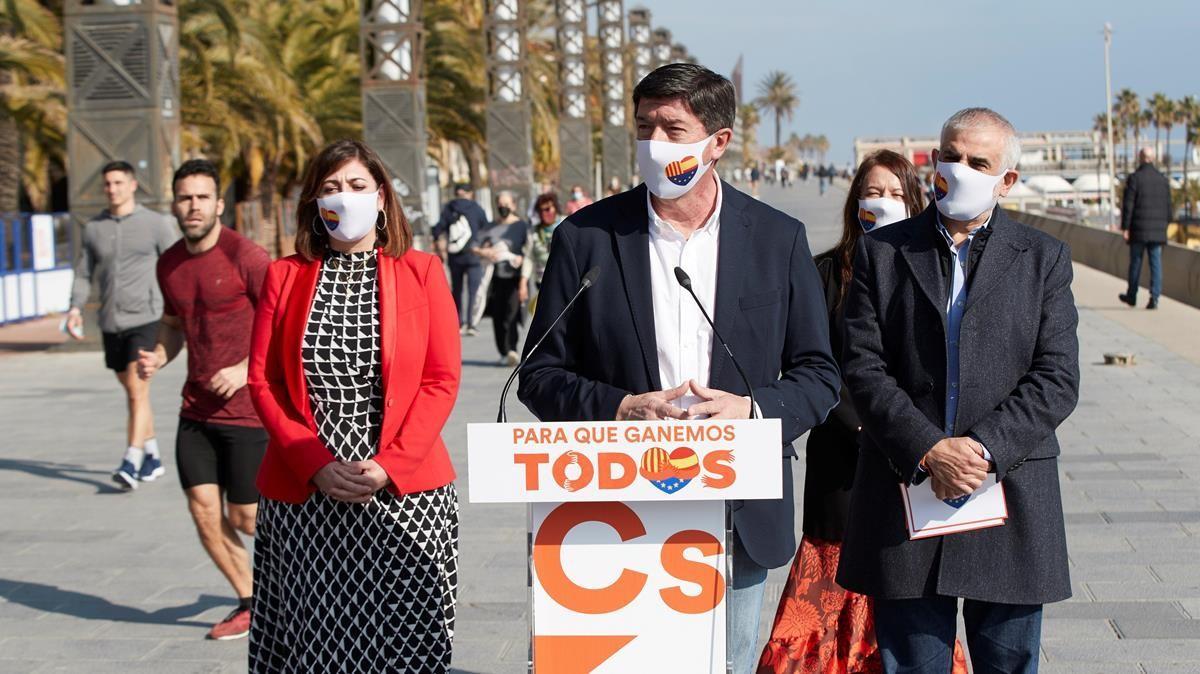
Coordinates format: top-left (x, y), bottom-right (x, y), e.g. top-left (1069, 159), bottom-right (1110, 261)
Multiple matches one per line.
top-left (517, 183), bottom-right (840, 567)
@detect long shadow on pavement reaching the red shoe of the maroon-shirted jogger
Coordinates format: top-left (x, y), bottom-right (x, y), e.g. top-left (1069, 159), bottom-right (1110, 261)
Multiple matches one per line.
top-left (0, 578), bottom-right (230, 627)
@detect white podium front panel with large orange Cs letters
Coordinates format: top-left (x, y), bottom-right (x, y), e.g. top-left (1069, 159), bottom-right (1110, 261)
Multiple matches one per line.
top-left (533, 501), bottom-right (726, 674)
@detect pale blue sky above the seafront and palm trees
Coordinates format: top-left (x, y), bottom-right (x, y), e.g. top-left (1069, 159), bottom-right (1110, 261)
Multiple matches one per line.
top-left (648, 0), bottom-right (1200, 163)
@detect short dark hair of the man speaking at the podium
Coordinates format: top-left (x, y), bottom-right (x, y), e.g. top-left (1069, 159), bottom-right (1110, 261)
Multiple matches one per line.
top-left (634, 64), bottom-right (738, 133)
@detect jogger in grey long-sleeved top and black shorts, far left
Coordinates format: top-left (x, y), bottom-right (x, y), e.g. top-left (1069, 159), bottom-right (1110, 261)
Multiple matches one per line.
top-left (67, 161), bottom-right (179, 492)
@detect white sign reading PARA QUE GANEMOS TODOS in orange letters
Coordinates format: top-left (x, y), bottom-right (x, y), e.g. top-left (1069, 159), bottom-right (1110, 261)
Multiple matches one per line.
top-left (467, 419), bottom-right (782, 503)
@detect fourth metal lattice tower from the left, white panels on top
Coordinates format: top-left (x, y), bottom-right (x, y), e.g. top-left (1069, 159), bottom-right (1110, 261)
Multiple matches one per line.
top-left (556, 0), bottom-right (593, 195)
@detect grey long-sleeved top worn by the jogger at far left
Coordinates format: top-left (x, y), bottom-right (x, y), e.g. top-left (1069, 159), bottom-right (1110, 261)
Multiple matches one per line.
top-left (71, 204), bottom-right (179, 332)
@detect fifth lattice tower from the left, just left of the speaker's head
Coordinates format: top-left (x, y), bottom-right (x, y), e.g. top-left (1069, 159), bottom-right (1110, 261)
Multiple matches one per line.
top-left (598, 0), bottom-right (632, 188)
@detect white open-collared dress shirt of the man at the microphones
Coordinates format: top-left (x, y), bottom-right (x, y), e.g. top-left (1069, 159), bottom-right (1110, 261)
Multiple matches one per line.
top-left (646, 181), bottom-right (721, 409)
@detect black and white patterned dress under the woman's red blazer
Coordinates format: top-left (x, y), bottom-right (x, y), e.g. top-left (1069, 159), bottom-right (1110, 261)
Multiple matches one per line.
top-left (250, 252), bottom-right (458, 673)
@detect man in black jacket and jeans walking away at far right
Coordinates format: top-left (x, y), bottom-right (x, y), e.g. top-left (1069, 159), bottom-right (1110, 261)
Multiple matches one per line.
top-left (1120, 148), bottom-right (1171, 309)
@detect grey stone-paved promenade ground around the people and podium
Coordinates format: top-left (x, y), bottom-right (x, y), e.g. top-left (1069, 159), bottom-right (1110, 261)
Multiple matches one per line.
top-left (0, 181), bottom-right (1200, 674)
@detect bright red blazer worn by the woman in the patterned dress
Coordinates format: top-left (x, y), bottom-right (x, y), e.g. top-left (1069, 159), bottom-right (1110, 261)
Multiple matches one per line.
top-left (247, 251), bottom-right (462, 503)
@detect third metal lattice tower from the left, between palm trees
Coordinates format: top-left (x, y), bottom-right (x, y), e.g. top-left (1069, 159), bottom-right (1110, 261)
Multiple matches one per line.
top-left (485, 0), bottom-right (533, 212)
